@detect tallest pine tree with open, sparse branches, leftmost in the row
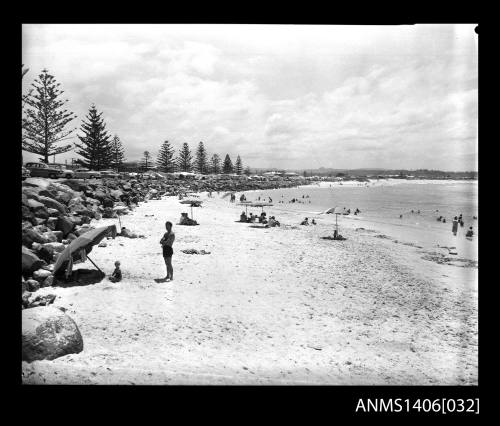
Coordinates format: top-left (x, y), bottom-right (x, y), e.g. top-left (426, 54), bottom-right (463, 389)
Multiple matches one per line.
top-left (22, 69), bottom-right (76, 163)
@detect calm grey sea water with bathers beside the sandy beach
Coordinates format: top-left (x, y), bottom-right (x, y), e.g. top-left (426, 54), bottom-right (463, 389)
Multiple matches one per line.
top-left (237, 180), bottom-right (478, 233)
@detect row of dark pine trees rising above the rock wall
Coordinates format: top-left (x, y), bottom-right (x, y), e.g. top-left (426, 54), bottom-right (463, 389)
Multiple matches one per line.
top-left (22, 66), bottom-right (250, 175)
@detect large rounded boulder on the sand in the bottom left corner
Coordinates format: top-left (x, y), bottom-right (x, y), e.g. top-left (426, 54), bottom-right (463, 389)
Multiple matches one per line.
top-left (22, 306), bottom-right (83, 362)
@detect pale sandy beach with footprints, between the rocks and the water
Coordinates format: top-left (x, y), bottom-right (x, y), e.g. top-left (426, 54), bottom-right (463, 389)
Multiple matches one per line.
top-left (23, 196), bottom-right (478, 385)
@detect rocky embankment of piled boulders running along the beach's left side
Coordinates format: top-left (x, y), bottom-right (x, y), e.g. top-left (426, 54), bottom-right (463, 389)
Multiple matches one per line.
top-left (22, 178), bottom-right (306, 361)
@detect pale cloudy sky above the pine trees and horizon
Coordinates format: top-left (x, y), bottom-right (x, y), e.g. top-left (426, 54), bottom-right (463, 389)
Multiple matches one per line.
top-left (22, 24), bottom-right (478, 171)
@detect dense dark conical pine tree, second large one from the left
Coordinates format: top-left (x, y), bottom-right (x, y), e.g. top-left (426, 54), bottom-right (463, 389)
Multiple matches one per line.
top-left (75, 104), bottom-right (113, 170)
